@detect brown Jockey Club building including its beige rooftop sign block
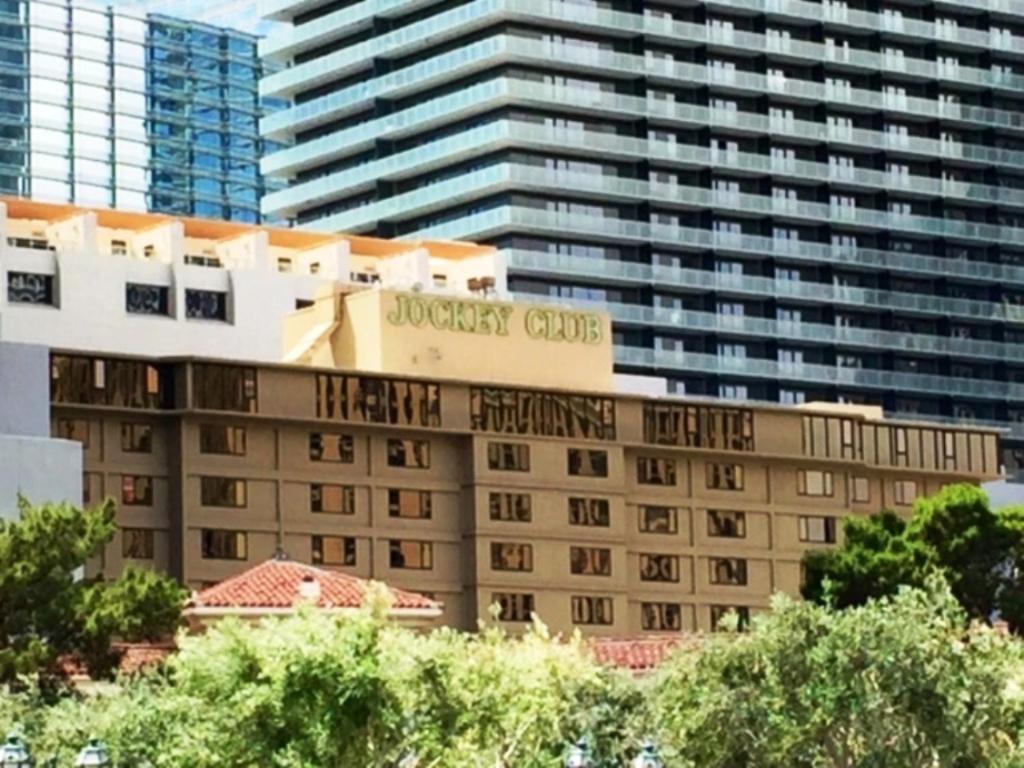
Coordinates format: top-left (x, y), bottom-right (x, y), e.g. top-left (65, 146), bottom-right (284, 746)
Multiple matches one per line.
top-left (50, 290), bottom-right (999, 636)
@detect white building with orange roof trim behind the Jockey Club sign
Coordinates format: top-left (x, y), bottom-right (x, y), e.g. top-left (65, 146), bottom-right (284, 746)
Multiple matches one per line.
top-left (0, 199), bottom-right (505, 361)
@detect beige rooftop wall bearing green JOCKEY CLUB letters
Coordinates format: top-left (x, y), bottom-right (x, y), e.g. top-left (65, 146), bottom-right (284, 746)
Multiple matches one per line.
top-left (332, 291), bottom-right (612, 390)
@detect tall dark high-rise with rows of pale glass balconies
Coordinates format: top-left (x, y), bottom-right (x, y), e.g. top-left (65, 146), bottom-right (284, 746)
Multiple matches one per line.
top-left (261, 0), bottom-right (1024, 471)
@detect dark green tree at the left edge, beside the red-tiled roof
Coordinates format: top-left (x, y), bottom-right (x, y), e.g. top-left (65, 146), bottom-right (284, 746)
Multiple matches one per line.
top-left (0, 499), bottom-right (185, 683)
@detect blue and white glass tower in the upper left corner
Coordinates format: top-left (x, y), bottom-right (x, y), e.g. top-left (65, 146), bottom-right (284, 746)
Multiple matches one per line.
top-left (0, 0), bottom-right (276, 222)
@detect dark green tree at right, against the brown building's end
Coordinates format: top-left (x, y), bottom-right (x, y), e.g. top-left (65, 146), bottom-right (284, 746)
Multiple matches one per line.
top-left (803, 484), bottom-right (1024, 631)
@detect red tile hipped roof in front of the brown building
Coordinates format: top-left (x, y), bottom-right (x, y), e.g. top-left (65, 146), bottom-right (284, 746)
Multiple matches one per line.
top-left (186, 558), bottom-right (440, 611)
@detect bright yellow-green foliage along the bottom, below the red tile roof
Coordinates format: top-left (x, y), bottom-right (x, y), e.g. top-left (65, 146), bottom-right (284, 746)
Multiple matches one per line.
top-left (0, 611), bottom-right (641, 768)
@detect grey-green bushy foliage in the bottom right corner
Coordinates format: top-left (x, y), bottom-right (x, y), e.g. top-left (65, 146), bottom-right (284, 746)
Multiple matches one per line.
top-left (652, 583), bottom-right (1024, 768)
